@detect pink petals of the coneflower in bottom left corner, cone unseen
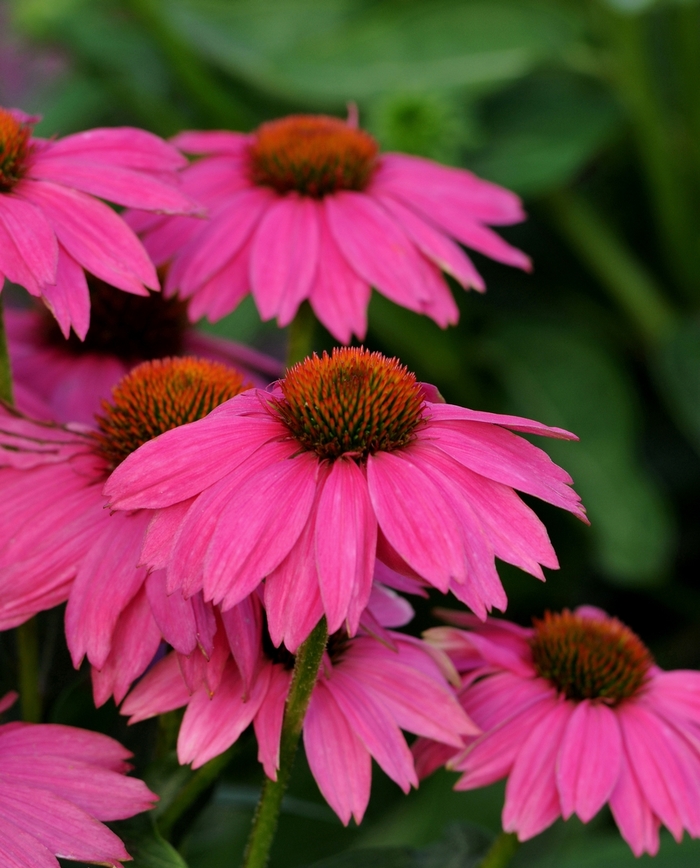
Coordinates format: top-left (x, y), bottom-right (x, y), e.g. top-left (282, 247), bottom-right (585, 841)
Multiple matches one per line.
top-left (0, 723), bottom-right (158, 868)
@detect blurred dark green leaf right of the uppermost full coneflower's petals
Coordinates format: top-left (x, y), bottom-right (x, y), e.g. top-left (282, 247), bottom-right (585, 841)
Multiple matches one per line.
top-left (469, 72), bottom-right (622, 195)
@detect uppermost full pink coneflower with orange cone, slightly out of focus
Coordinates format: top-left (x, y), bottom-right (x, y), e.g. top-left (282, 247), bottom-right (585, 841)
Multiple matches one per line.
top-left (130, 115), bottom-right (530, 343)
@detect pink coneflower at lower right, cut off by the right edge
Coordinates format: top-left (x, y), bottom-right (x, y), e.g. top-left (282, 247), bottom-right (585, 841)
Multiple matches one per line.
top-left (415, 606), bottom-right (700, 856)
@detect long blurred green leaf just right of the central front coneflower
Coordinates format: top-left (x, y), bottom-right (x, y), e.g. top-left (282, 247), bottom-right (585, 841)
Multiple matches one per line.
top-left (490, 321), bottom-right (674, 584)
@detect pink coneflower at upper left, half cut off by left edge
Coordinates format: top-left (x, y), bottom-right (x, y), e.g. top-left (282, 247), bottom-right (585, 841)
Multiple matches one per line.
top-left (0, 108), bottom-right (197, 338)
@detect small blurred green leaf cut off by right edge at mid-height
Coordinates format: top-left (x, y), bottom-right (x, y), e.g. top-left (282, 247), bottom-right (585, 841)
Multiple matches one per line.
top-left (655, 319), bottom-right (700, 451)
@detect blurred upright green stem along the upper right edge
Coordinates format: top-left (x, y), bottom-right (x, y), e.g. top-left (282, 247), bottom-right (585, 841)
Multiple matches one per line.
top-left (607, 11), bottom-right (700, 301)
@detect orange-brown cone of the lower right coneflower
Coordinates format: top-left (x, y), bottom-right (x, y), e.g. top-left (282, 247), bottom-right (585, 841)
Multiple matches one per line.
top-left (530, 609), bottom-right (654, 705)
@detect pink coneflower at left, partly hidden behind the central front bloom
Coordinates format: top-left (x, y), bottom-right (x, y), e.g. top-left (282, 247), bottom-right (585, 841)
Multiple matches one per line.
top-left (0, 358), bottom-right (252, 702)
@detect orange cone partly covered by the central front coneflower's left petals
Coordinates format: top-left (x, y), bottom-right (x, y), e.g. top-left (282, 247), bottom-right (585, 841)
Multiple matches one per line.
top-left (95, 357), bottom-right (250, 468)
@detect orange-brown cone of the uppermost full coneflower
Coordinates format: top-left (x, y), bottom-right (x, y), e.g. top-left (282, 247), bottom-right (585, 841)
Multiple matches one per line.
top-left (248, 115), bottom-right (379, 198)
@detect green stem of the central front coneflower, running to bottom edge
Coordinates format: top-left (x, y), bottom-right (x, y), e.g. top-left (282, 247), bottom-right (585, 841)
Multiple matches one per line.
top-left (243, 618), bottom-right (328, 868)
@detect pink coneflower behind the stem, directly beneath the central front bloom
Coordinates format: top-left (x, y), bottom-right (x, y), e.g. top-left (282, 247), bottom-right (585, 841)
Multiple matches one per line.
top-left (121, 589), bottom-right (479, 825)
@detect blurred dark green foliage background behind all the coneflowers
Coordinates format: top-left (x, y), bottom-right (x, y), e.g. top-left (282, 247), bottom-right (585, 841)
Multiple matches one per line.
top-left (0, 0), bottom-right (700, 868)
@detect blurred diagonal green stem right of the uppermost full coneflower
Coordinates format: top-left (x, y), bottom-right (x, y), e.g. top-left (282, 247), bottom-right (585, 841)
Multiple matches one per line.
top-left (548, 190), bottom-right (676, 344)
